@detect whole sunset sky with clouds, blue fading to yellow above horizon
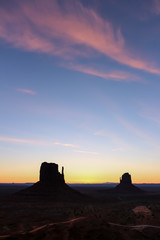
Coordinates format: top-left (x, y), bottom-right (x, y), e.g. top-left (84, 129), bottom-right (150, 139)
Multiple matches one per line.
top-left (0, 0), bottom-right (160, 183)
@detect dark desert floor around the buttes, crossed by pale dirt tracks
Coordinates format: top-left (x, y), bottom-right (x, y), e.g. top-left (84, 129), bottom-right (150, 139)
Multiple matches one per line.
top-left (0, 184), bottom-right (160, 240)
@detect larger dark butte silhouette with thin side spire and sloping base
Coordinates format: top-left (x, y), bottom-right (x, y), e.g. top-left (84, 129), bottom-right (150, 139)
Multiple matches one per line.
top-left (18, 162), bottom-right (85, 201)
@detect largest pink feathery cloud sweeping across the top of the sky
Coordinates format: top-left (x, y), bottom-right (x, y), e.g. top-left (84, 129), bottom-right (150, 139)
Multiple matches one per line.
top-left (0, 0), bottom-right (160, 75)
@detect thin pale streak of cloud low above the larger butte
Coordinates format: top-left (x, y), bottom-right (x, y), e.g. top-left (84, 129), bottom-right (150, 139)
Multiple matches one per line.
top-left (0, 137), bottom-right (78, 148)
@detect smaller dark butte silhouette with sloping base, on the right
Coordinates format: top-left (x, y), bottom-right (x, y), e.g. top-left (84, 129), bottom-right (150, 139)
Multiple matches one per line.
top-left (114, 173), bottom-right (143, 193)
